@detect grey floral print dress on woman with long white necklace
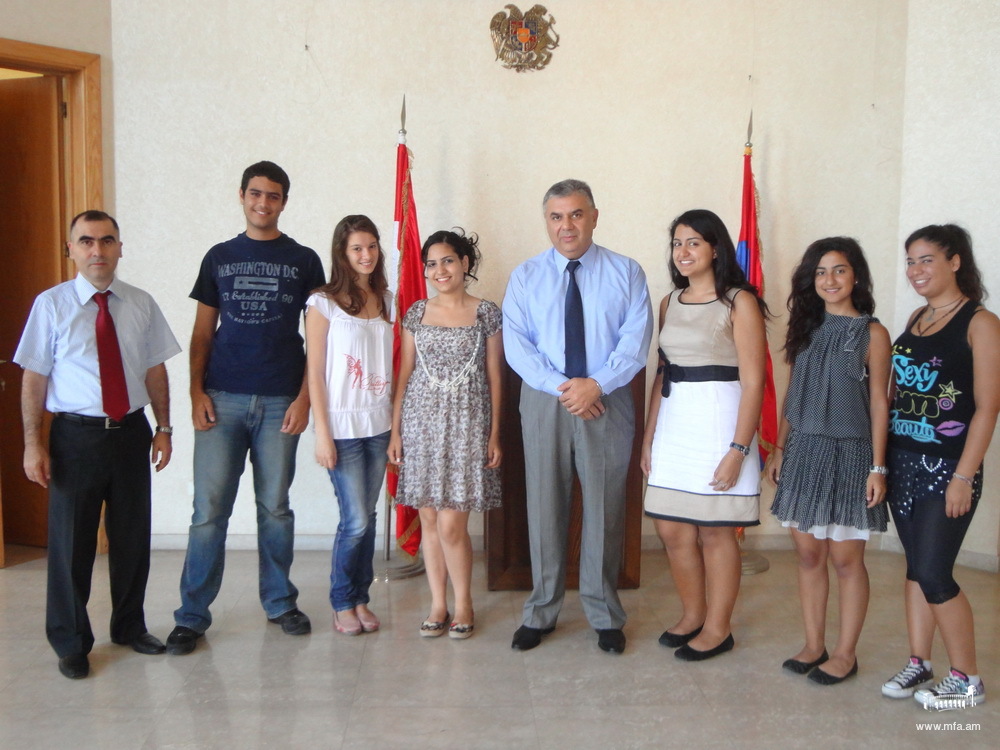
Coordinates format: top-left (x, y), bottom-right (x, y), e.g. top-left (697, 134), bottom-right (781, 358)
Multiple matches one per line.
top-left (396, 300), bottom-right (503, 511)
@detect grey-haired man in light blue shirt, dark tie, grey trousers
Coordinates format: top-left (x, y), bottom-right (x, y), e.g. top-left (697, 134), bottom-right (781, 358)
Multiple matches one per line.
top-left (503, 180), bottom-right (653, 653)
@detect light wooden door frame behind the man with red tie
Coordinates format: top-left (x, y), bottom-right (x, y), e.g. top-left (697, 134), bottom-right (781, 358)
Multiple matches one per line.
top-left (0, 37), bottom-right (107, 568)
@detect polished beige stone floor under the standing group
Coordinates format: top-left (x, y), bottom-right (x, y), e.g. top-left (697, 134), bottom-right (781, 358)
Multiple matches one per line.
top-left (0, 550), bottom-right (1000, 750)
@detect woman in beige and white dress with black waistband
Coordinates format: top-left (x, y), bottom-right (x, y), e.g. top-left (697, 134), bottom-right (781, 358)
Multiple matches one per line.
top-left (642, 209), bottom-right (767, 661)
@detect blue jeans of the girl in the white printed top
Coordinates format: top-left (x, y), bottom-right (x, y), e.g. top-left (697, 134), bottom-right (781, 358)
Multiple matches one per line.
top-left (330, 432), bottom-right (389, 612)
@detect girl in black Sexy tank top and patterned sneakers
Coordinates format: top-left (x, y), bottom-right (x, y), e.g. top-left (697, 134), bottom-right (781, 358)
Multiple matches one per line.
top-left (882, 224), bottom-right (1000, 709)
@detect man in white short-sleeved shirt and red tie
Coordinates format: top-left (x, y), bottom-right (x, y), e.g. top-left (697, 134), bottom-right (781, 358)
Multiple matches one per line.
top-left (14, 211), bottom-right (181, 679)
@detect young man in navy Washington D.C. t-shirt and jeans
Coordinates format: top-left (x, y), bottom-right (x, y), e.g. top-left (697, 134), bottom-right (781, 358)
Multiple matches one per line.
top-left (167, 161), bottom-right (326, 654)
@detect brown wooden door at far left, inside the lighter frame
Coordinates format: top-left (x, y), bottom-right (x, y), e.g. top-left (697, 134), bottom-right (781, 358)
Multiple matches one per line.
top-left (0, 76), bottom-right (64, 547)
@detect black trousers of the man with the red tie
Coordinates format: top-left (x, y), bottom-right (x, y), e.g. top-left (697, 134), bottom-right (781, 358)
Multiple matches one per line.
top-left (45, 410), bottom-right (152, 657)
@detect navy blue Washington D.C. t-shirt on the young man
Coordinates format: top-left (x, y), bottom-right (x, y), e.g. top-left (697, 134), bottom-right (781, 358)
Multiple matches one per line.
top-left (191, 234), bottom-right (326, 398)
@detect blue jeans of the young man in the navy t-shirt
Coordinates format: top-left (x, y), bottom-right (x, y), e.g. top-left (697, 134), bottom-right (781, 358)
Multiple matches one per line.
top-left (174, 390), bottom-right (299, 633)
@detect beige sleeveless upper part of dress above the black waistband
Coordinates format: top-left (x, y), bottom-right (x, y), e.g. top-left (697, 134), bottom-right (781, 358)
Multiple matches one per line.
top-left (658, 289), bottom-right (740, 367)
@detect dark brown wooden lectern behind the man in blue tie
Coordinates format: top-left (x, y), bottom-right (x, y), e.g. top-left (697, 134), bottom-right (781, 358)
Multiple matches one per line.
top-left (485, 363), bottom-right (646, 591)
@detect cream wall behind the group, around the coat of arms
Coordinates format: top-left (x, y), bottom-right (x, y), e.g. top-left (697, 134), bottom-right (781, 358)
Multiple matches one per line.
top-left (0, 0), bottom-right (1000, 560)
